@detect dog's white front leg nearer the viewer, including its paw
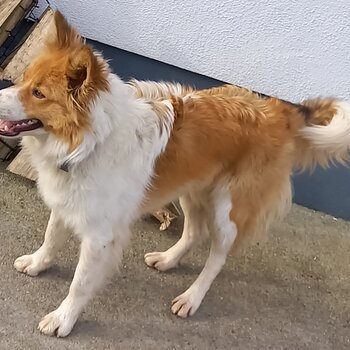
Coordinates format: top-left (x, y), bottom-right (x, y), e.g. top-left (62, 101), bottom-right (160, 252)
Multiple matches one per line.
top-left (38, 234), bottom-right (122, 337)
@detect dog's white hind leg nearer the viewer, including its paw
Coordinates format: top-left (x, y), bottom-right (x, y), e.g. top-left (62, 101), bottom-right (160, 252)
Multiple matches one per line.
top-left (171, 187), bottom-right (237, 317)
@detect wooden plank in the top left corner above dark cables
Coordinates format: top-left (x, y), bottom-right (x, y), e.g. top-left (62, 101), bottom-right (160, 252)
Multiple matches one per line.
top-left (0, 0), bottom-right (34, 45)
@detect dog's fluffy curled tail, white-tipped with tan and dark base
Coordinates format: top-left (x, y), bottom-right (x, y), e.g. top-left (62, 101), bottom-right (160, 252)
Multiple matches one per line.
top-left (296, 99), bottom-right (350, 170)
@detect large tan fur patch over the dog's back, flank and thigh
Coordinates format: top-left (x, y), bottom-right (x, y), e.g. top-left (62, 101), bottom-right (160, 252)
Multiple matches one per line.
top-left (141, 86), bottom-right (303, 244)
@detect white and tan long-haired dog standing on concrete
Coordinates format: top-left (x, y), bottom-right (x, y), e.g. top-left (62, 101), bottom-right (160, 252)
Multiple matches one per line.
top-left (0, 12), bottom-right (350, 337)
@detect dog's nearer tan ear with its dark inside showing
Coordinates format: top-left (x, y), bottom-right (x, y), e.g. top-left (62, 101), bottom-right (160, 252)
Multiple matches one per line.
top-left (66, 45), bottom-right (109, 109)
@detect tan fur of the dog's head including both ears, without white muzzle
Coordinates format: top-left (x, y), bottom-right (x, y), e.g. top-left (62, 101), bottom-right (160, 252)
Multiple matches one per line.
top-left (19, 12), bottom-right (109, 151)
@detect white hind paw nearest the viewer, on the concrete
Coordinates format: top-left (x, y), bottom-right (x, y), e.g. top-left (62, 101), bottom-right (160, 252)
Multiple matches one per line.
top-left (171, 289), bottom-right (203, 318)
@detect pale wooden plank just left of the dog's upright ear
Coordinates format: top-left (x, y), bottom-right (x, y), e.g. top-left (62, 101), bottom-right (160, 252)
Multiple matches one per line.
top-left (0, 9), bottom-right (53, 83)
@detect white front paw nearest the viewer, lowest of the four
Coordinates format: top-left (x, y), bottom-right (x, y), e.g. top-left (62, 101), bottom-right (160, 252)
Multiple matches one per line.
top-left (38, 308), bottom-right (77, 337)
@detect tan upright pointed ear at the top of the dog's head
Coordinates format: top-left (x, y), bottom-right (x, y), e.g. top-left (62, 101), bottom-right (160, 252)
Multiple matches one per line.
top-left (48, 11), bottom-right (83, 48)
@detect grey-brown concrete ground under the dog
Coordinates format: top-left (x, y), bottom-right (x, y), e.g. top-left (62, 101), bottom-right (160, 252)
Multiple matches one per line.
top-left (0, 165), bottom-right (350, 350)
